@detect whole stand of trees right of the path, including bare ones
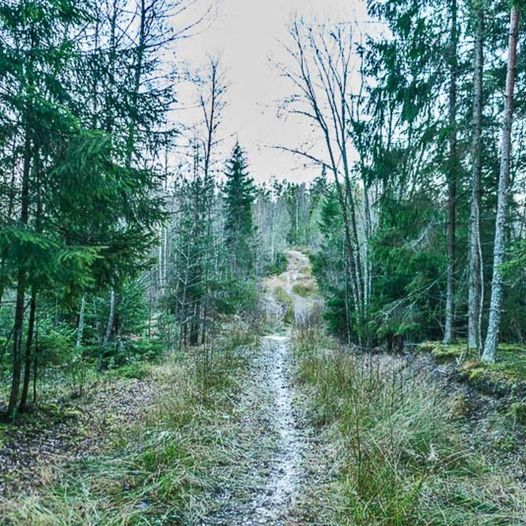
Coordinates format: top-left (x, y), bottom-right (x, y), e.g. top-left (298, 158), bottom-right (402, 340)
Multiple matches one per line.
top-left (279, 0), bottom-right (525, 362)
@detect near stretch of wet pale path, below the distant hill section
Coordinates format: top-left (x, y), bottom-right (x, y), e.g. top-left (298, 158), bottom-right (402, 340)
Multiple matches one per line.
top-left (206, 335), bottom-right (310, 526)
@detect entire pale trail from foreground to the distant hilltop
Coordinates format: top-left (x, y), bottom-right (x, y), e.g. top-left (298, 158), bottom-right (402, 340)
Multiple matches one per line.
top-left (208, 250), bottom-right (320, 526)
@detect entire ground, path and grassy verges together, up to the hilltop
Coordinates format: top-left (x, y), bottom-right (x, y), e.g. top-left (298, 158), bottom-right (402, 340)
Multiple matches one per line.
top-left (0, 254), bottom-right (526, 526)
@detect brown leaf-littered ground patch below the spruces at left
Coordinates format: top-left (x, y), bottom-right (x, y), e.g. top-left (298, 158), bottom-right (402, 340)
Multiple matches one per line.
top-left (0, 377), bottom-right (159, 502)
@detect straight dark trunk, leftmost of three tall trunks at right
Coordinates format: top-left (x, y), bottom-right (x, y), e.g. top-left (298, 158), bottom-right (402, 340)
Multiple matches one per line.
top-left (444, 0), bottom-right (458, 343)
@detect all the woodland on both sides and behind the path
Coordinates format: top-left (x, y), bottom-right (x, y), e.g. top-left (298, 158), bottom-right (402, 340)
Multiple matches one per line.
top-left (0, 0), bottom-right (526, 524)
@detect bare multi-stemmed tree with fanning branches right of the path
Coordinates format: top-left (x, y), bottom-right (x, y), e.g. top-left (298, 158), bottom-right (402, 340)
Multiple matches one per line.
top-left (279, 20), bottom-right (368, 342)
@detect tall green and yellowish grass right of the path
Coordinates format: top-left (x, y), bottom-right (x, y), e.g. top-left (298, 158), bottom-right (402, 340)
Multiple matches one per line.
top-left (293, 326), bottom-right (526, 526)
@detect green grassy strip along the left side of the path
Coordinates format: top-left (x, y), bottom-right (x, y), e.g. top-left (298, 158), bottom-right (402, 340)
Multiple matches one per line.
top-left (0, 327), bottom-right (256, 526)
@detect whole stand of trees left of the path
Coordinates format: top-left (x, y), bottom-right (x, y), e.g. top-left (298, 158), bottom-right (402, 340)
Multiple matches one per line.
top-left (0, 0), bottom-right (306, 420)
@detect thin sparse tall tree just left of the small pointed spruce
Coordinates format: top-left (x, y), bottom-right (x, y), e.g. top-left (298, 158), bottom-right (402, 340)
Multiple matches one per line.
top-left (168, 58), bottom-right (226, 345)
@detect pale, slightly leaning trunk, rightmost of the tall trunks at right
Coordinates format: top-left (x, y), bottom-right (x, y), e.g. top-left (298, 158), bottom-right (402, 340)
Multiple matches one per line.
top-left (482, 5), bottom-right (520, 363)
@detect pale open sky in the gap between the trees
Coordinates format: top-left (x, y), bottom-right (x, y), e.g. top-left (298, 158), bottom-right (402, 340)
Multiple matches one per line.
top-left (177, 0), bottom-right (366, 186)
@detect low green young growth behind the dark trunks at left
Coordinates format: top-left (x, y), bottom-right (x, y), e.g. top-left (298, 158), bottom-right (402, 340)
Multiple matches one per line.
top-left (0, 283), bottom-right (167, 404)
